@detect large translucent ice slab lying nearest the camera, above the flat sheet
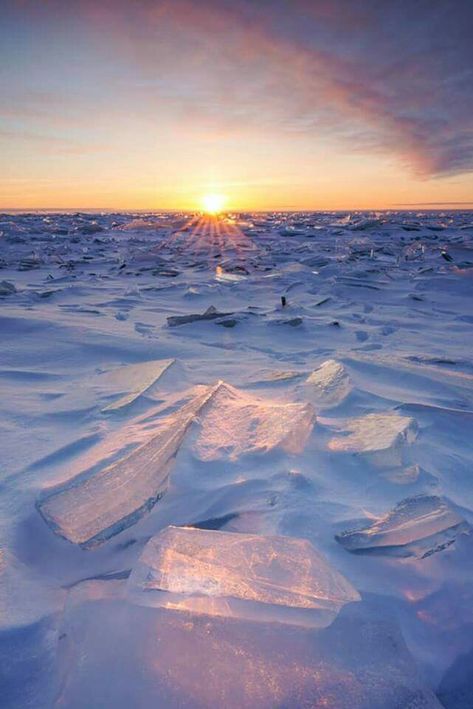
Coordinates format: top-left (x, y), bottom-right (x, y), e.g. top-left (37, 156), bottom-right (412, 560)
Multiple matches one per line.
top-left (128, 527), bottom-right (360, 626)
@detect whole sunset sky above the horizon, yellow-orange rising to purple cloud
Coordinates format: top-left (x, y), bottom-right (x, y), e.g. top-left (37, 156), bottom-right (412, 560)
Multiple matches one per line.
top-left (0, 0), bottom-right (473, 210)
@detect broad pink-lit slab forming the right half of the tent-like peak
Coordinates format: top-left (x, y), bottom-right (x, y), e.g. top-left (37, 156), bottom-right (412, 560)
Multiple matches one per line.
top-left (194, 382), bottom-right (316, 460)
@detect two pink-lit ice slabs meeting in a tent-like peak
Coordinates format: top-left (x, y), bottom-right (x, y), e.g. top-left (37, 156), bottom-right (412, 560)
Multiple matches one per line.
top-left (37, 382), bottom-right (316, 547)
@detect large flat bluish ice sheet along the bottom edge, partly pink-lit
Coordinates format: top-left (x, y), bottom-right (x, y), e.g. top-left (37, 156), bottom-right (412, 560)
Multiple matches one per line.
top-left (53, 600), bottom-right (440, 709)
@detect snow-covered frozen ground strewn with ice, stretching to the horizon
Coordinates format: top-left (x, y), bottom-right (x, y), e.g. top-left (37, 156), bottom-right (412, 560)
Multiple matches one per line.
top-left (0, 212), bottom-right (473, 709)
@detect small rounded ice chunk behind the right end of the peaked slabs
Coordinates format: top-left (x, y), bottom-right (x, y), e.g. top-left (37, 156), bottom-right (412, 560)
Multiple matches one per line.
top-left (304, 359), bottom-right (352, 408)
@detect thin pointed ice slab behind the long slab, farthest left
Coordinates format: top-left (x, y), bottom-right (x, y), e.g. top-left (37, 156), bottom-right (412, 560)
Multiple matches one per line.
top-left (100, 359), bottom-right (176, 412)
